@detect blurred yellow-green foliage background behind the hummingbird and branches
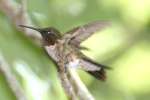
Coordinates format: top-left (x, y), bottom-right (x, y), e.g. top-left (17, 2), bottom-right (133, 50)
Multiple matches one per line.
top-left (0, 0), bottom-right (150, 100)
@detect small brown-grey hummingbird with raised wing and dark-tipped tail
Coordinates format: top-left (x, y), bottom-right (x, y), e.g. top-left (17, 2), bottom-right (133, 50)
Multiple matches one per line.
top-left (19, 21), bottom-right (110, 81)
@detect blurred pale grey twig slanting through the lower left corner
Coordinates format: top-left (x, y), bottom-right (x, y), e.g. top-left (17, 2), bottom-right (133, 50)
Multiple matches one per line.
top-left (0, 54), bottom-right (27, 100)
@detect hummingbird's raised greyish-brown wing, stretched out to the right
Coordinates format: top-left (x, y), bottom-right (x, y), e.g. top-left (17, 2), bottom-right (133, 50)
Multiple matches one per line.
top-left (64, 21), bottom-right (110, 45)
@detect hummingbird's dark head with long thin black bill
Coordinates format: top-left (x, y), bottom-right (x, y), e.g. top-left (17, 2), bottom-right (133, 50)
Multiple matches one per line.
top-left (19, 25), bottom-right (61, 45)
